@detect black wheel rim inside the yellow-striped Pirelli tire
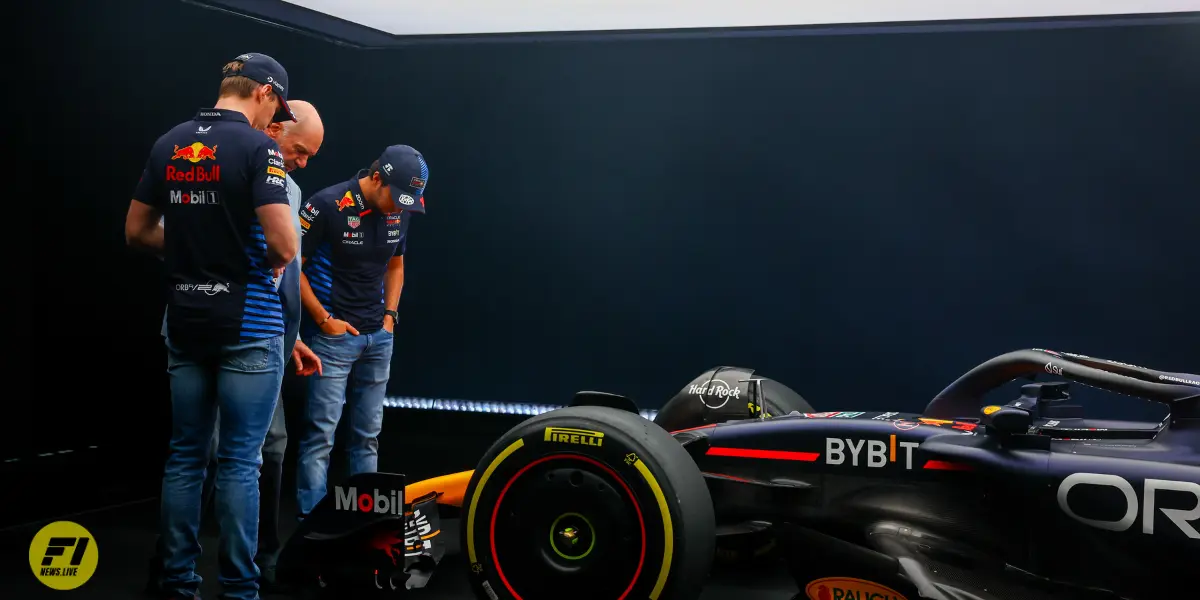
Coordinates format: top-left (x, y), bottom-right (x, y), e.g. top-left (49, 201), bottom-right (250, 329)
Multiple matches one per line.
top-left (490, 455), bottom-right (647, 600)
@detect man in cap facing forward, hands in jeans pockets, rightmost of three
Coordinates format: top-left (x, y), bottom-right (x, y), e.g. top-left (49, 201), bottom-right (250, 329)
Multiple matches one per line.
top-left (296, 145), bottom-right (430, 517)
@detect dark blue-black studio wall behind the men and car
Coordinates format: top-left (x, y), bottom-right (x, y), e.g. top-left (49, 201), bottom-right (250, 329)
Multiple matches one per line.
top-left (5, 0), bottom-right (1200, 520)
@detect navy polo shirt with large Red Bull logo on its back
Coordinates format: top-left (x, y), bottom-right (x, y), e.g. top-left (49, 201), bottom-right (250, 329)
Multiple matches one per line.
top-left (133, 108), bottom-right (288, 344)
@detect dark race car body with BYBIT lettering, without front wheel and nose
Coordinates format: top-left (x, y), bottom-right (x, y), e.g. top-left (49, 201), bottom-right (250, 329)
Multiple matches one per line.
top-left (664, 349), bottom-right (1200, 600)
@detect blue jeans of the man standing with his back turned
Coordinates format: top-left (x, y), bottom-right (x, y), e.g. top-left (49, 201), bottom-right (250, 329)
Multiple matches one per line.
top-left (160, 336), bottom-right (284, 600)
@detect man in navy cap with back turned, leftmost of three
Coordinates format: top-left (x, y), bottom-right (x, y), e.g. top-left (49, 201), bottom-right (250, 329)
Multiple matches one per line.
top-left (125, 54), bottom-right (300, 600)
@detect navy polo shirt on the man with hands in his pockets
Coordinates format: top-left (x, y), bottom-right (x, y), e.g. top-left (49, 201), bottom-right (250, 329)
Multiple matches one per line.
top-left (300, 169), bottom-right (424, 334)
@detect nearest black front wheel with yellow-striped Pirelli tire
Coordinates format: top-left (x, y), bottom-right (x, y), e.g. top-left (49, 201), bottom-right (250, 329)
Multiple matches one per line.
top-left (462, 406), bottom-right (716, 600)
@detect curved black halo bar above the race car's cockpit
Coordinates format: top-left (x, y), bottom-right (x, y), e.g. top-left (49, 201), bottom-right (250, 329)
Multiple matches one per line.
top-left (924, 348), bottom-right (1200, 424)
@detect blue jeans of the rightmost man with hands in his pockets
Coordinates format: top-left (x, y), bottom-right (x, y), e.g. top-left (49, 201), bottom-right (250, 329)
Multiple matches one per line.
top-left (296, 329), bottom-right (392, 518)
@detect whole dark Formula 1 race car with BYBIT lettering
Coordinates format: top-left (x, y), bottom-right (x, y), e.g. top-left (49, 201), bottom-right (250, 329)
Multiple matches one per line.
top-left (280, 349), bottom-right (1200, 600)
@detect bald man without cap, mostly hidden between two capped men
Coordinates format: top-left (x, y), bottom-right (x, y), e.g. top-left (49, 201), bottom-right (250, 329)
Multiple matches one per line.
top-left (148, 100), bottom-right (325, 594)
